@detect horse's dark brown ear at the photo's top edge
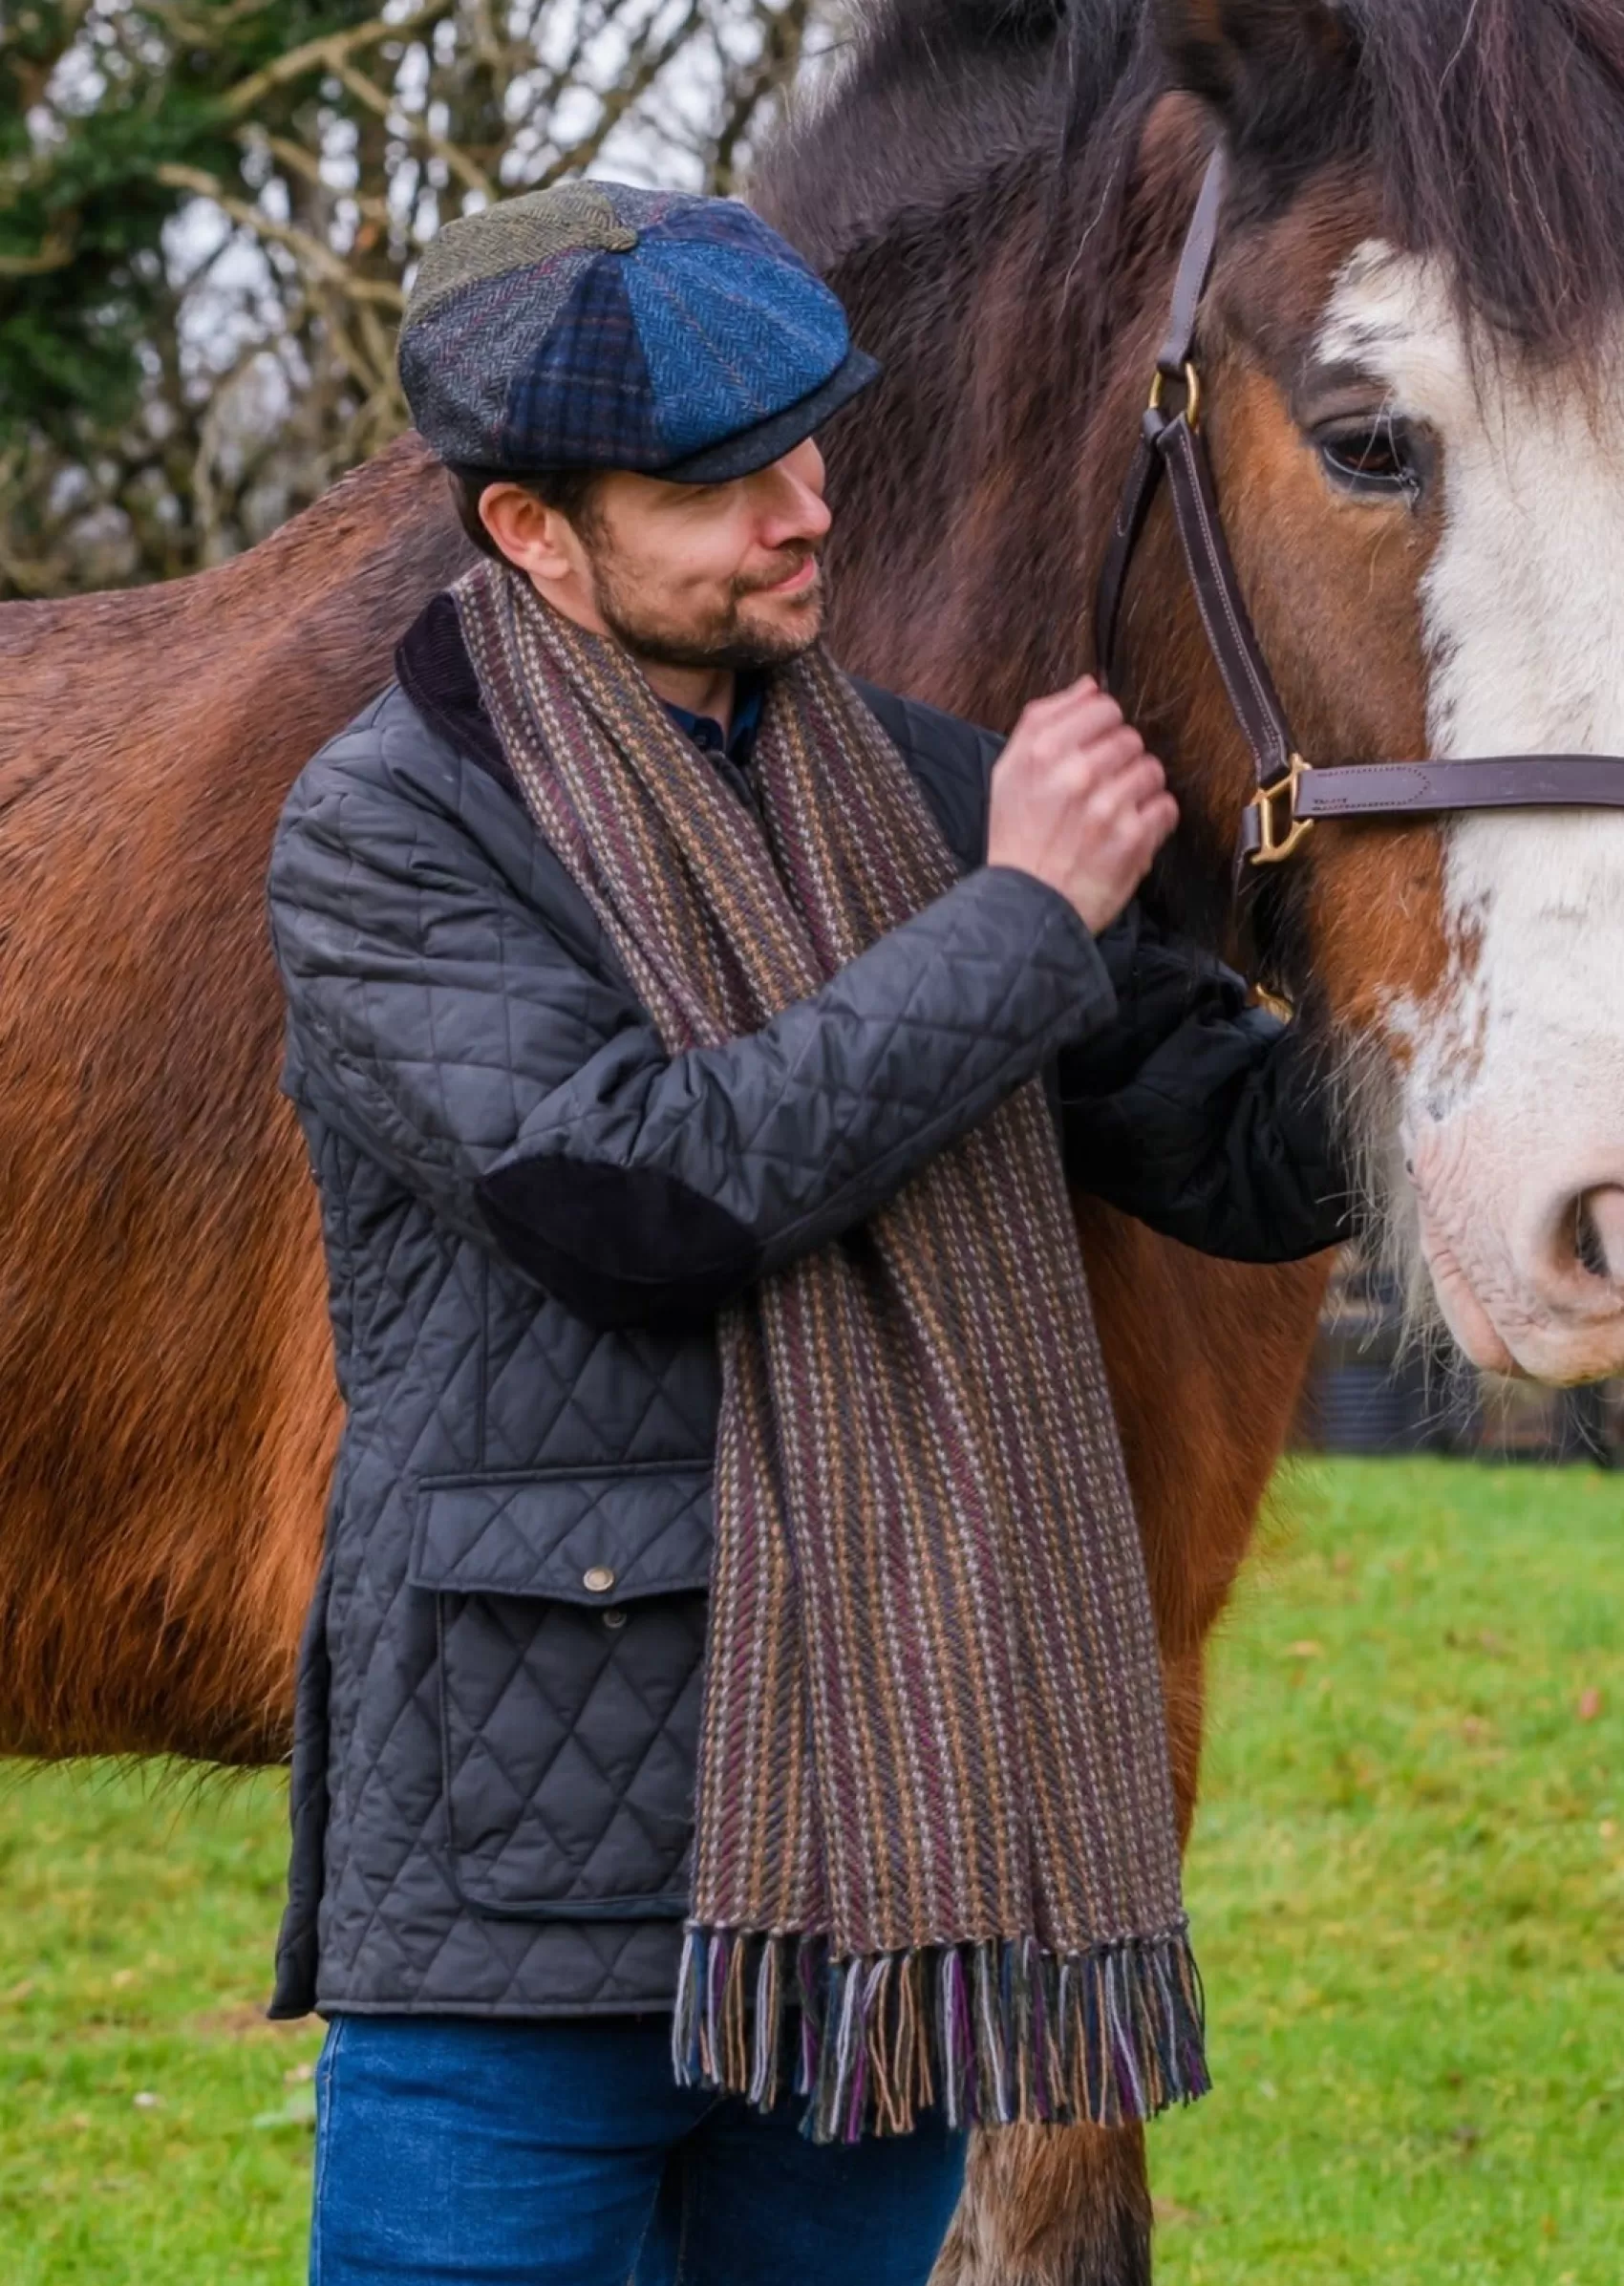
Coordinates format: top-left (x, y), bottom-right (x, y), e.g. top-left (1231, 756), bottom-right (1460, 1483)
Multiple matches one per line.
top-left (1155, 0), bottom-right (1358, 153)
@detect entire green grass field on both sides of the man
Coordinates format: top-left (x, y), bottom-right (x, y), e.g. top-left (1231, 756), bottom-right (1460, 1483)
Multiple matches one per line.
top-left (0, 1463), bottom-right (1624, 2286)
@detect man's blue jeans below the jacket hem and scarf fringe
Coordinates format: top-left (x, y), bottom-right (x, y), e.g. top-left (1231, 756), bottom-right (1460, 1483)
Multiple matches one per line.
top-left (311, 2017), bottom-right (965, 2286)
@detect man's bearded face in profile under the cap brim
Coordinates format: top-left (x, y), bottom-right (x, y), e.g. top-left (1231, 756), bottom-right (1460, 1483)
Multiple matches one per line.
top-left (574, 437), bottom-right (830, 670)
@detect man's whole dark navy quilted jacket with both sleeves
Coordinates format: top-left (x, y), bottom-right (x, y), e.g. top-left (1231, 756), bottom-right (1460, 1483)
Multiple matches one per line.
top-left (270, 599), bottom-right (1342, 2017)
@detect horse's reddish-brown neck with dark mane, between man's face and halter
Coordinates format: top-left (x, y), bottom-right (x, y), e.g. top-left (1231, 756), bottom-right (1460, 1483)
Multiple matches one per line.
top-left (753, 0), bottom-right (1199, 727)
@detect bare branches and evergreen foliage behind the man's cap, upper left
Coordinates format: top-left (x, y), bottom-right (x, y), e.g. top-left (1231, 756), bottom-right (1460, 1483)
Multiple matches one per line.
top-left (0, 0), bottom-right (830, 597)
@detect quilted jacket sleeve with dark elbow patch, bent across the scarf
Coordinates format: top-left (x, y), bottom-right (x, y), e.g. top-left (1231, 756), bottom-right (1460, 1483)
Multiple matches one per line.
top-left (270, 740), bottom-right (1116, 1326)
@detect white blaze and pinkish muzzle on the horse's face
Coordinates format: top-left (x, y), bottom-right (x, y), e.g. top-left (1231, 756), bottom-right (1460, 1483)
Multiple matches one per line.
top-left (1317, 243), bottom-right (1624, 1380)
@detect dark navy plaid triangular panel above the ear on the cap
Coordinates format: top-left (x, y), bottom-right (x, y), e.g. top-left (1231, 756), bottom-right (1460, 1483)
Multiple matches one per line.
top-left (501, 254), bottom-right (671, 469)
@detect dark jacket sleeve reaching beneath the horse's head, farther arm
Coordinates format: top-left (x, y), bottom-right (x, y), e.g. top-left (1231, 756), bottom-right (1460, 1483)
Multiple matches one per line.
top-left (1059, 912), bottom-right (1354, 1262)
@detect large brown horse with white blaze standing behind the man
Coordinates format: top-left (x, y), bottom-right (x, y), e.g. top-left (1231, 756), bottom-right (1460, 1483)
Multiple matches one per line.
top-left (0, 0), bottom-right (1624, 2286)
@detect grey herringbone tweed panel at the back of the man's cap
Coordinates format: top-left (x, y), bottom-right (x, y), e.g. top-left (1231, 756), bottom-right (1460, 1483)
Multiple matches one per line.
top-left (400, 249), bottom-right (604, 469)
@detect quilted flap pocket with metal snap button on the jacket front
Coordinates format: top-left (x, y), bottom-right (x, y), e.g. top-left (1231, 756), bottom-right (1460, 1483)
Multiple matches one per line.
top-left (410, 1461), bottom-right (712, 1920)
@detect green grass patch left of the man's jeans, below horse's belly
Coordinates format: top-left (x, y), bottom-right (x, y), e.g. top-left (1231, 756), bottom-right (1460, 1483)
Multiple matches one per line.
top-left (0, 1772), bottom-right (320, 2286)
